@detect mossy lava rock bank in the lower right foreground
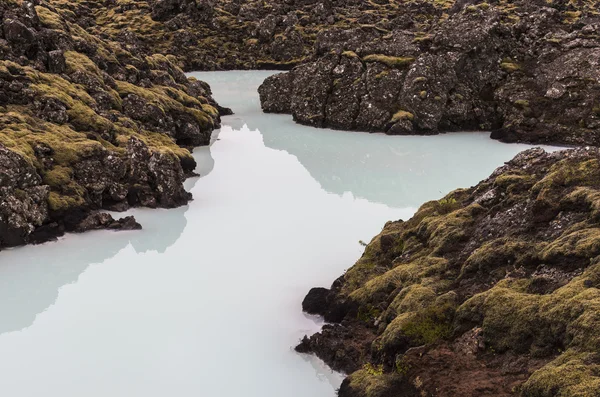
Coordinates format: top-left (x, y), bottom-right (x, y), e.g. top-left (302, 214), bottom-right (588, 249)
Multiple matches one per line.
top-left (297, 148), bottom-right (600, 397)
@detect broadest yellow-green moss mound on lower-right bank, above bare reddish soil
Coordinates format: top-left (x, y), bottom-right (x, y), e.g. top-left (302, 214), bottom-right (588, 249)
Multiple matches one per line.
top-left (457, 264), bottom-right (600, 356)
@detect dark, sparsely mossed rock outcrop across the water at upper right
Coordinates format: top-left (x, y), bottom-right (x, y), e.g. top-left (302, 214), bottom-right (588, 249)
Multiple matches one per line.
top-left (259, 1), bottom-right (600, 145)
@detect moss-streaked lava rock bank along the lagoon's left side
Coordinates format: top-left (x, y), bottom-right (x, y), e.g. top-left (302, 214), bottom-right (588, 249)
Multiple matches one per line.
top-left (0, 0), bottom-right (227, 249)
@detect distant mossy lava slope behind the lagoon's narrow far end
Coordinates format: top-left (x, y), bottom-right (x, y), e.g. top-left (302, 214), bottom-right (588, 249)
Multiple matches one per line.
top-left (52, 0), bottom-right (414, 70)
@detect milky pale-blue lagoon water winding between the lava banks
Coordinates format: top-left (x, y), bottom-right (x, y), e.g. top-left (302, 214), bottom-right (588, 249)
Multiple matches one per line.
top-left (0, 72), bottom-right (556, 397)
